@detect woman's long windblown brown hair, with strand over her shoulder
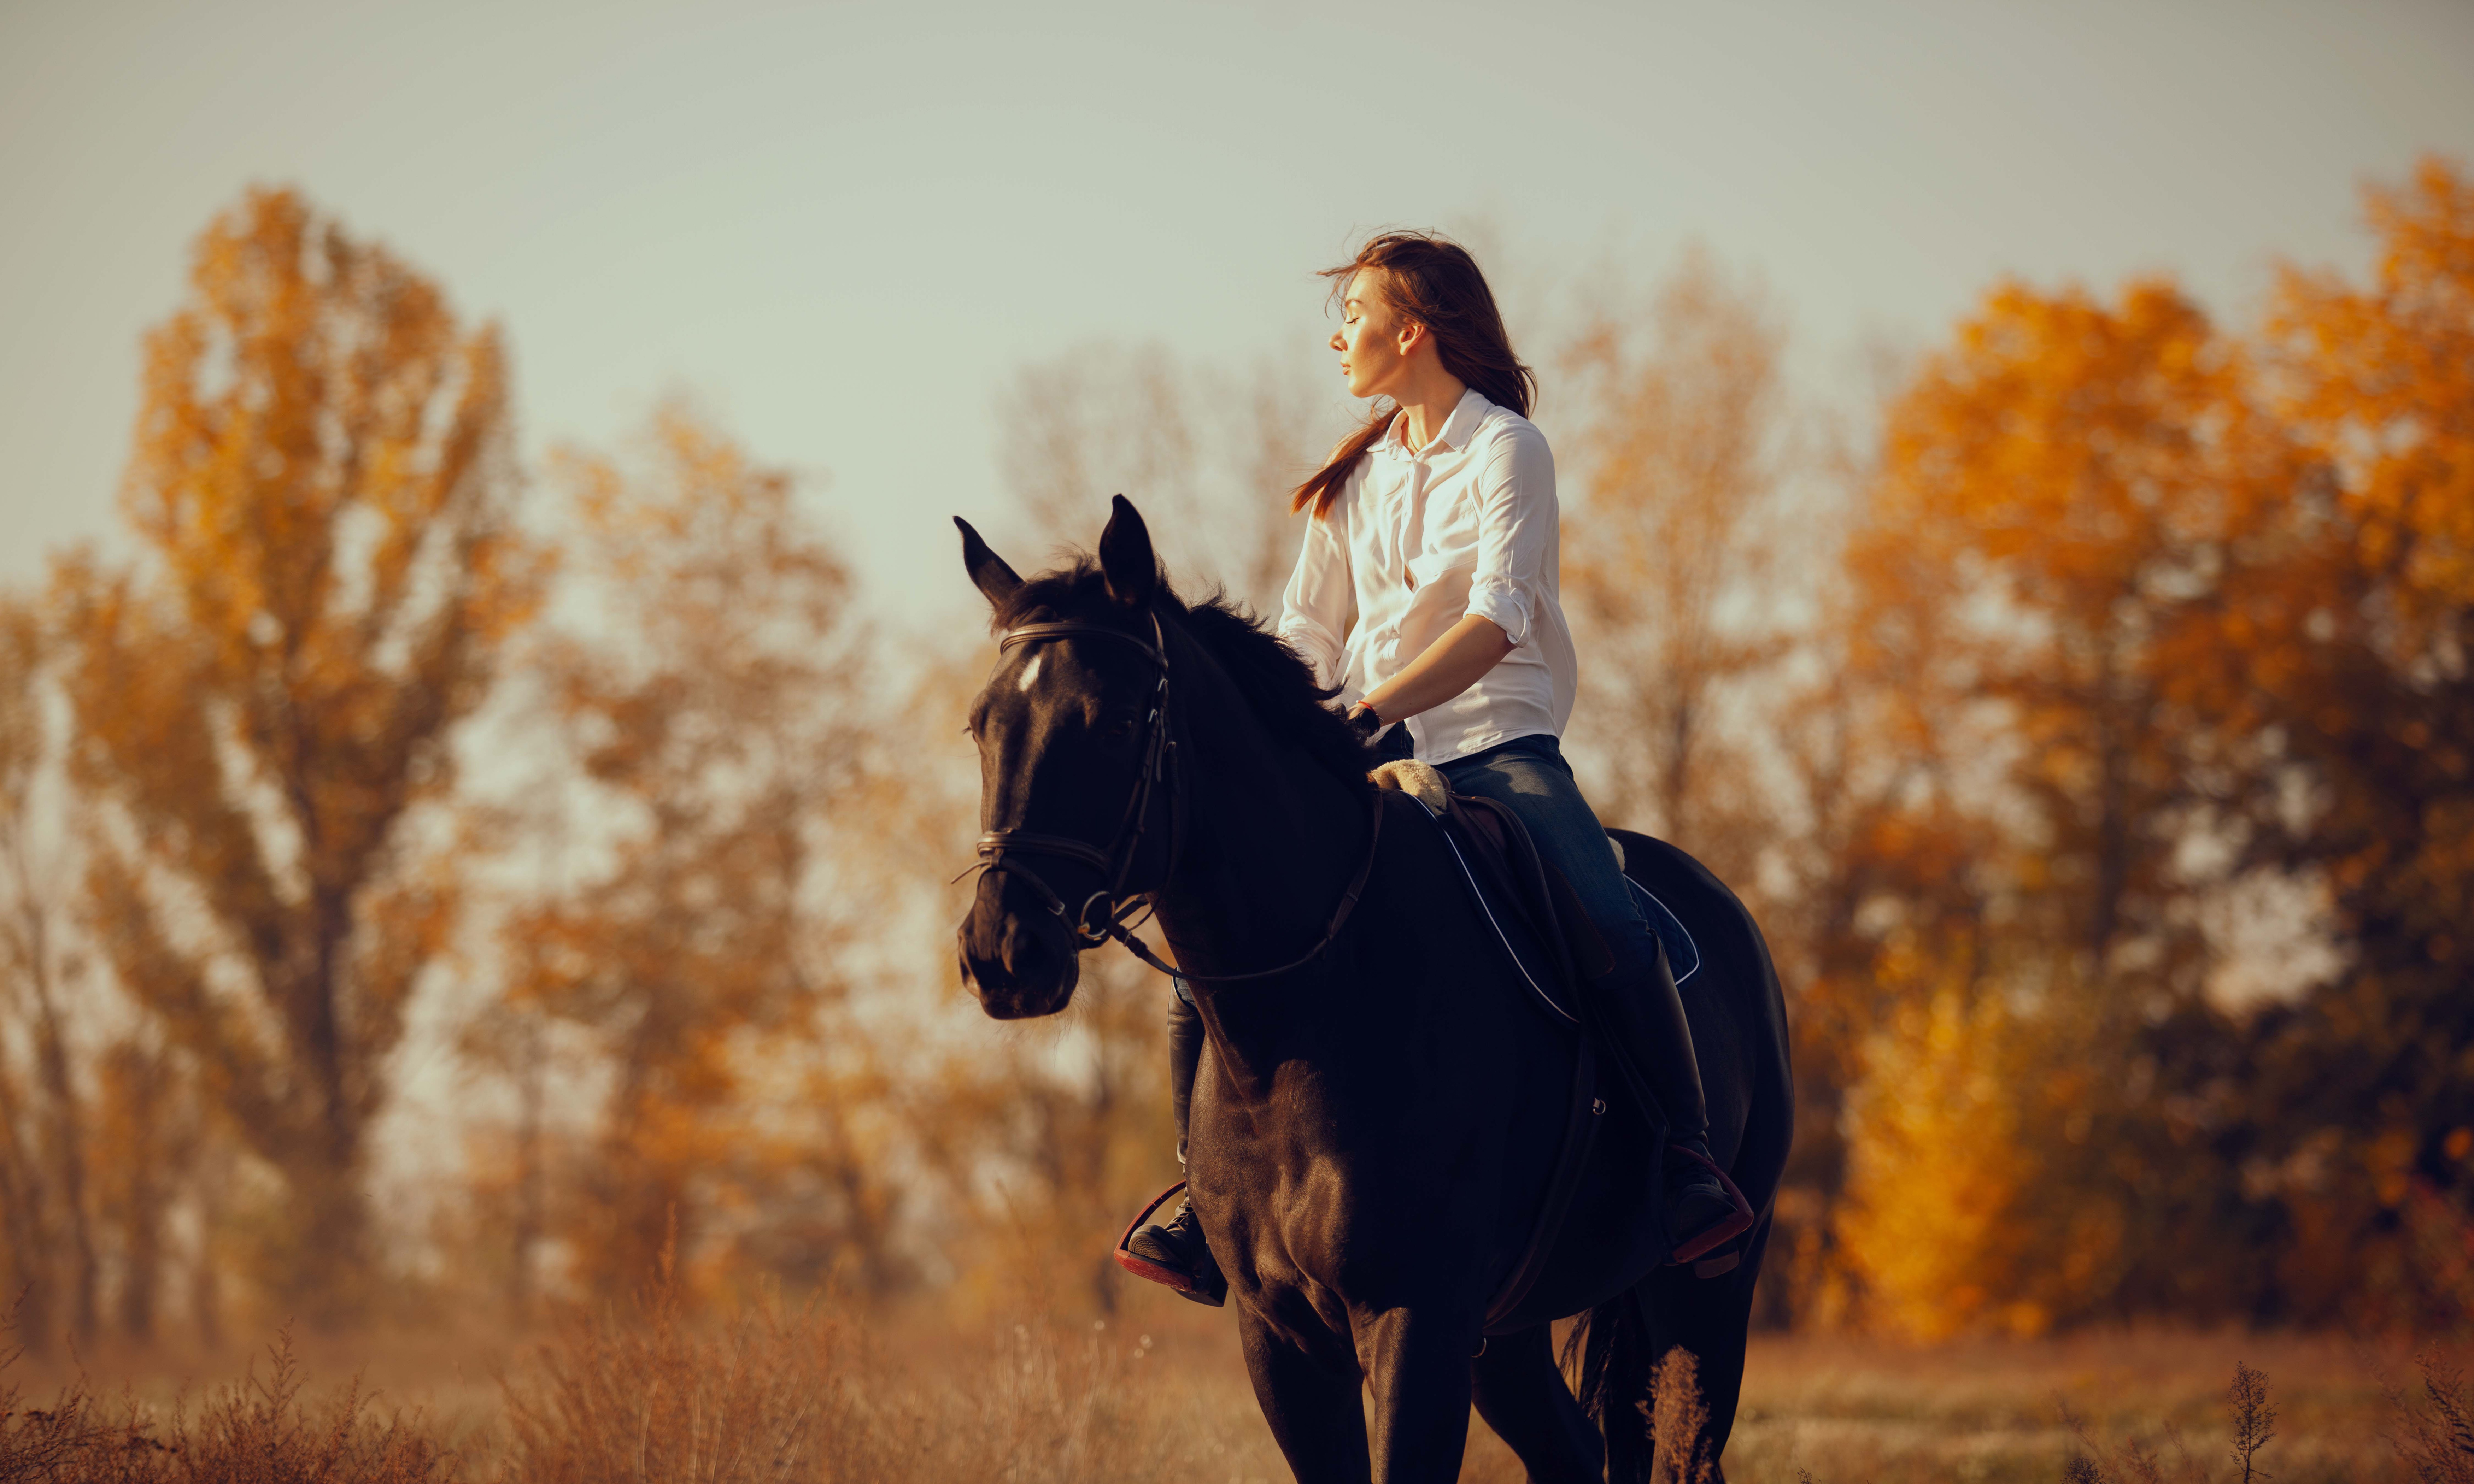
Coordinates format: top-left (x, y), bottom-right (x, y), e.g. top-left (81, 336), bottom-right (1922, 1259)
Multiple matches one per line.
top-left (1289, 232), bottom-right (1539, 517)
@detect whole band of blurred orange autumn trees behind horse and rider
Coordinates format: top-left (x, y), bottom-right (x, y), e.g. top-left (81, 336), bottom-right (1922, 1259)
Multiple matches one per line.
top-left (0, 161), bottom-right (2474, 1338)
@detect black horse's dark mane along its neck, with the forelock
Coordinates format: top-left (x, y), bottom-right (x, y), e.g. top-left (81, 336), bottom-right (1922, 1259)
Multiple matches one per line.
top-left (990, 552), bottom-right (1373, 789)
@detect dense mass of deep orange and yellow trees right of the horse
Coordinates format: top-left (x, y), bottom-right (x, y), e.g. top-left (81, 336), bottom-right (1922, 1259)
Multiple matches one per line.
top-left (1826, 163), bottom-right (2474, 1333)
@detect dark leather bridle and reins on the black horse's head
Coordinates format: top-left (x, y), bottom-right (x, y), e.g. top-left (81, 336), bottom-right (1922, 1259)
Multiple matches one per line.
top-left (962, 613), bottom-right (1383, 984)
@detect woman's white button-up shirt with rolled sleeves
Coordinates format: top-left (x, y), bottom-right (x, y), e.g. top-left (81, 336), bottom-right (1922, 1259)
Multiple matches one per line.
top-left (1279, 388), bottom-right (1581, 764)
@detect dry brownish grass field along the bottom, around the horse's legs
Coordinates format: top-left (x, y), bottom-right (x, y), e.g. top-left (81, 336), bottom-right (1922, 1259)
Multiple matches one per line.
top-left (0, 1294), bottom-right (2447, 1484)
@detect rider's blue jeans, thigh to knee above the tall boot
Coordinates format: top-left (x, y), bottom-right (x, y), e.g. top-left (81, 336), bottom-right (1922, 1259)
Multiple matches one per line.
top-left (1435, 737), bottom-right (1697, 982)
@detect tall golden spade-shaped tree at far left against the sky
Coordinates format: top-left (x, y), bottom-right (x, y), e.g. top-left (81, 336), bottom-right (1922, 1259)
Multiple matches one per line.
top-left (57, 190), bottom-right (534, 1323)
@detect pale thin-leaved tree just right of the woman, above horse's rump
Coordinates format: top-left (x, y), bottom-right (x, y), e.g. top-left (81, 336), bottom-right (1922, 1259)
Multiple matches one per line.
top-left (1561, 247), bottom-right (1799, 883)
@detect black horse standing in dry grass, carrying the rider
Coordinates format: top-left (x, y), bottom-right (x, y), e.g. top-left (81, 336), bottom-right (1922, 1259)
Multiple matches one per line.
top-left (955, 497), bottom-right (1791, 1482)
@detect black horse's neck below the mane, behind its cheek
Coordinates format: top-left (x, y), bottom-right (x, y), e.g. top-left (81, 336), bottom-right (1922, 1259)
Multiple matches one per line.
top-left (1158, 633), bottom-right (1371, 1081)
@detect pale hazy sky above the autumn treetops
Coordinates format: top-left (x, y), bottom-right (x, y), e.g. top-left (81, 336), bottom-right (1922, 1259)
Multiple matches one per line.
top-left (0, 0), bottom-right (2474, 618)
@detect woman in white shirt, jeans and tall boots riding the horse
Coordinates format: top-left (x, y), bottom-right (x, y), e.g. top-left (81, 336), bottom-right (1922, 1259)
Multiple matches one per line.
top-left (1126, 232), bottom-right (1752, 1306)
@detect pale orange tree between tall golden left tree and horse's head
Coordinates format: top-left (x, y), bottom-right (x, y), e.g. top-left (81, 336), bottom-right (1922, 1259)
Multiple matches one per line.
top-left (502, 403), bottom-right (901, 1294)
